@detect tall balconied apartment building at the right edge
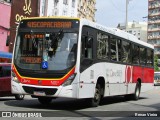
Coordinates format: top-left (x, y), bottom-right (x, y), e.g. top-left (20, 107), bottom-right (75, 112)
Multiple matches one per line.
top-left (148, 0), bottom-right (160, 57)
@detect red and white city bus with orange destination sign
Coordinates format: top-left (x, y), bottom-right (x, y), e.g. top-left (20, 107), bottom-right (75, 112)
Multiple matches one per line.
top-left (12, 17), bottom-right (154, 106)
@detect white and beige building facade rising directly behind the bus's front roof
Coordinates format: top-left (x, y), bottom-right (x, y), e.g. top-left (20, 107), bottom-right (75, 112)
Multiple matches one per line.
top-left (40, 0), bottom-right (96, 21)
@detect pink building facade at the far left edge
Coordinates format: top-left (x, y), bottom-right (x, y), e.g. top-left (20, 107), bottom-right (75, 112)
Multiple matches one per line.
top-left (0, 0), bottom-right (11, 52)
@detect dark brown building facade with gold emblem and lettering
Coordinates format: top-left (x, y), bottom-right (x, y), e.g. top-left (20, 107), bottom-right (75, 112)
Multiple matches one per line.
top-left (9, 0), bottom-right (39, 52)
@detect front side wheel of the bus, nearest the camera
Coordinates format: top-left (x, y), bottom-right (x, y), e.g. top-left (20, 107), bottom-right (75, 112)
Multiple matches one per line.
top-left (89, 84), bottom-right (101, 107)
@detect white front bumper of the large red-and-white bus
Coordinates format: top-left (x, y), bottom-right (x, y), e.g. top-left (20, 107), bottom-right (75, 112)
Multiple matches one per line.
top-left (11, 80), bottom-right (77, 98)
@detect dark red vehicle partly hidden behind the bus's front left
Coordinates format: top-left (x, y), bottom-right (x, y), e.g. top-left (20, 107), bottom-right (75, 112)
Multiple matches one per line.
top-left (0, 63), bottom-right (24, 100)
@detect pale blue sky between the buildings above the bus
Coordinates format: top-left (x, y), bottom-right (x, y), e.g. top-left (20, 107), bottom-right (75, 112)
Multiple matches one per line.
top-left (95, 0), bottom-right (148, 27)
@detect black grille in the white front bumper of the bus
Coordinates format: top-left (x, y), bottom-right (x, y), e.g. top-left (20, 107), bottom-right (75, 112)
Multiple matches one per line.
top-left (23, 86), bottom-right (57, 95)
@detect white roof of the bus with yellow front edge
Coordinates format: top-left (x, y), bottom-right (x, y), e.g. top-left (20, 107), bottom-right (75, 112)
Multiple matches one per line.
top-left (20, 16), bottom-right (154, 49)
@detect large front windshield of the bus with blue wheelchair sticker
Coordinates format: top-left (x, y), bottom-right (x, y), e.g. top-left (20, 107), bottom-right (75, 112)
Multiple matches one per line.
top-left (14, 30), bottom-right (78, 70)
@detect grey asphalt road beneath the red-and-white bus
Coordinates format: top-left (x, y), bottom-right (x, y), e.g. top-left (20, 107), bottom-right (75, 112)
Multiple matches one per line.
top-left (0, 86), bottom-right (160, 120)
